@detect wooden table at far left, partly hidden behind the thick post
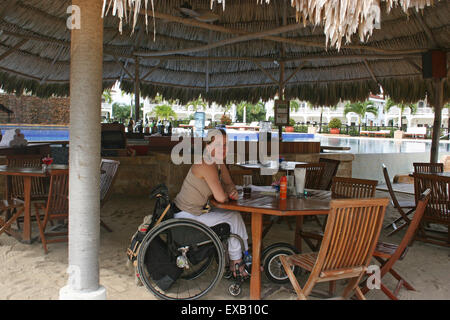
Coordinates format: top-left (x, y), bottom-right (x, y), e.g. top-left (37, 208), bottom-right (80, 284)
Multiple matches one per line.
top-left (0, 164), bottom-right (69, 244)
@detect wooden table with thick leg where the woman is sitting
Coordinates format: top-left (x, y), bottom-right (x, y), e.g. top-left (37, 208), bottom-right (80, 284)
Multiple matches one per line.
top-left (211, 190), bottom-right (331, 300)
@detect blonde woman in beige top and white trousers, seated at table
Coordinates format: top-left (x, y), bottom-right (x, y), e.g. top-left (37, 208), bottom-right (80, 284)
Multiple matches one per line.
top-left (174, 129), bottom-right (248, 277)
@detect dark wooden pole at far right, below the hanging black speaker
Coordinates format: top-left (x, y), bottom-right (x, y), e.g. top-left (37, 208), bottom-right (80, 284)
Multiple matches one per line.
top-left (430, 79), bottom-right (444, 163)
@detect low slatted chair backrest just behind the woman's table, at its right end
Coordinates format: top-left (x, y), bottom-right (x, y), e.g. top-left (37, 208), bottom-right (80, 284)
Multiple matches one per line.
top-left (331, 177), bottom-right (378, 199)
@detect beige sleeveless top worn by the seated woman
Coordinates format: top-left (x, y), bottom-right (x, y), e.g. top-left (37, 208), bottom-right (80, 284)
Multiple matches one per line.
top-left (174, 167), bottom-right (212, 216)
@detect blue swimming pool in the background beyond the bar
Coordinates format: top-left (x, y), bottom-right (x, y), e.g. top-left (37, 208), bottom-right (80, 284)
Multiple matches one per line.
top-left (0, 125), bottom-right (450, 154)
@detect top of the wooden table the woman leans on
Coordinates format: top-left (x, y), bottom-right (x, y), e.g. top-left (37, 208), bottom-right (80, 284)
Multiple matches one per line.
top-left (211, 190), bottom-right (331, 216)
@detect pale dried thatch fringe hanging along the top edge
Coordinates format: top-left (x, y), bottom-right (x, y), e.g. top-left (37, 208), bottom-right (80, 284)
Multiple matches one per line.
top-left (103, 0), bottom-right (433, 50)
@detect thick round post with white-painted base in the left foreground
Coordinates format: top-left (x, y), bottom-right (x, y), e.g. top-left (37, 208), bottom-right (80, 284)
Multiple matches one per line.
top-left (59, 0), bottom-right (106, 300)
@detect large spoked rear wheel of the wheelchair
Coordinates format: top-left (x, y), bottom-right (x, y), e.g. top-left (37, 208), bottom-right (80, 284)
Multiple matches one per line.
top-left (137, 219), bottom-right (225, 300)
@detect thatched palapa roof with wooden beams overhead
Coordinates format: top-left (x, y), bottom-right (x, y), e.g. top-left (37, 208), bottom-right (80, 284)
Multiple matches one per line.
top-left (0, 0), bottom-right (450, 105)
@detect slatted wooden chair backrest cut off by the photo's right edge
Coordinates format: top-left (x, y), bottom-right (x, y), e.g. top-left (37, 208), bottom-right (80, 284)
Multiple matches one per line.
top-left (414, 173), bottom-right (450, 225)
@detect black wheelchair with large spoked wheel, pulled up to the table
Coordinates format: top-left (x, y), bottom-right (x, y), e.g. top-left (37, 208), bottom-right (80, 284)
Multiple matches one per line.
top-left (136, 218), bottom-right (299, 300)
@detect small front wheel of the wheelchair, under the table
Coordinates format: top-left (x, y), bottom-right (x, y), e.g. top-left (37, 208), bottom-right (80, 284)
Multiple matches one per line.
top-left (262, 242), bottom-right (299, 284)
